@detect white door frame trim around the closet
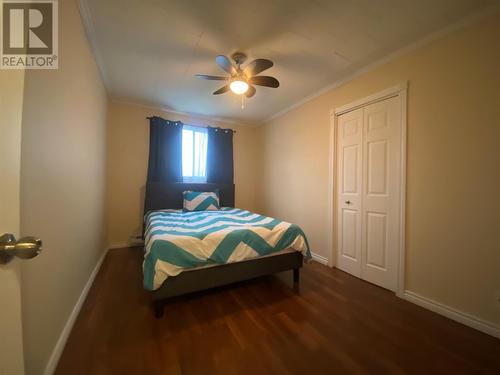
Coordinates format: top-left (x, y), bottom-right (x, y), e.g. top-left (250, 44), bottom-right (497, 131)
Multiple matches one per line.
top-left (328, 81), bottom-right (408, 298)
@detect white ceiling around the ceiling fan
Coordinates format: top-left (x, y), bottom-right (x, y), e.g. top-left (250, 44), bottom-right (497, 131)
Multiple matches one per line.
top-left (82, 0), bottom-right (498, 123)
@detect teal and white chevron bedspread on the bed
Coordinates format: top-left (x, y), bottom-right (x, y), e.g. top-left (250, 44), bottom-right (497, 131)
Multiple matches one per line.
top-left (143, 207), bottom-right (311, 290)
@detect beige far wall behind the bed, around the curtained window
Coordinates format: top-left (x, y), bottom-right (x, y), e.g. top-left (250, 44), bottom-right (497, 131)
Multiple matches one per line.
top-left (107, 103), bottom-right (258, 246)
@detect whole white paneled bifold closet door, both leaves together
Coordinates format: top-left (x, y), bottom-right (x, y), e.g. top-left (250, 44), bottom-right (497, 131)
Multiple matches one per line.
top-left (337, 97), bottom-right (401, 291)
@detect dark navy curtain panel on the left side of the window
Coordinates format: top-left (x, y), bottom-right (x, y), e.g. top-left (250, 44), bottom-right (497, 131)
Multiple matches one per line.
top-left (148, 117), bottom-right (182, 182)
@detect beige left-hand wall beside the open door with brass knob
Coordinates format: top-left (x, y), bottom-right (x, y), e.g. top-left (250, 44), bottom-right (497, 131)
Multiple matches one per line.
top-left (21, 1), bottom-right (107, 375)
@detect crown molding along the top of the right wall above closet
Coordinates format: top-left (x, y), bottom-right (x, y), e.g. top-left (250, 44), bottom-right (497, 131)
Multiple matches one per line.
top-left (257, 5), bottom-right (500, 126)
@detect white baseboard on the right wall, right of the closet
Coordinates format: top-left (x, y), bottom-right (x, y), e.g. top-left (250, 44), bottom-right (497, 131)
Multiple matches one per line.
top-left (403, 290), bottom-right (500, 338)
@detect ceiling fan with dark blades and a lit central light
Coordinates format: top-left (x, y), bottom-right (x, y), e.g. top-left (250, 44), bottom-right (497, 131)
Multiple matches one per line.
top-left (196, 52), bottom-right (280, 98)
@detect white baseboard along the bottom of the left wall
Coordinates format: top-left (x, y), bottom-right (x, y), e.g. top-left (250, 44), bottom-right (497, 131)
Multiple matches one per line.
top-left (43, 250), bottom-right (108, 375)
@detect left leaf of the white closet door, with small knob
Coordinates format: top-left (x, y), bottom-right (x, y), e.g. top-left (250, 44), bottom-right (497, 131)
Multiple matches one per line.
top-left (337, 109), bottom-right (363, 277)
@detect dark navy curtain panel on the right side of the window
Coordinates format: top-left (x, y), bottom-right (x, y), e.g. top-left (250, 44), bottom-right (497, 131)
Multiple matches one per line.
top-left (207, 128), bottom-right (234, 184)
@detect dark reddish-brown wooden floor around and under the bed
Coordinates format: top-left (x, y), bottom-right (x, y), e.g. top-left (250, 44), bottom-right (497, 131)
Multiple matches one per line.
top-left (56, 248), bottom-right (500, 375)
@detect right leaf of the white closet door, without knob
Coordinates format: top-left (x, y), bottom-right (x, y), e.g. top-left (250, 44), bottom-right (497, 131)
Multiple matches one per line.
top-left (361, 97), bottom-right (401, 291)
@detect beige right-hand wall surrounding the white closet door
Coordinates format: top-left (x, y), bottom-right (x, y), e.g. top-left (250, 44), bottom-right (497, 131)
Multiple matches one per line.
top-left (258, 13), bottom-right (500, 324)
